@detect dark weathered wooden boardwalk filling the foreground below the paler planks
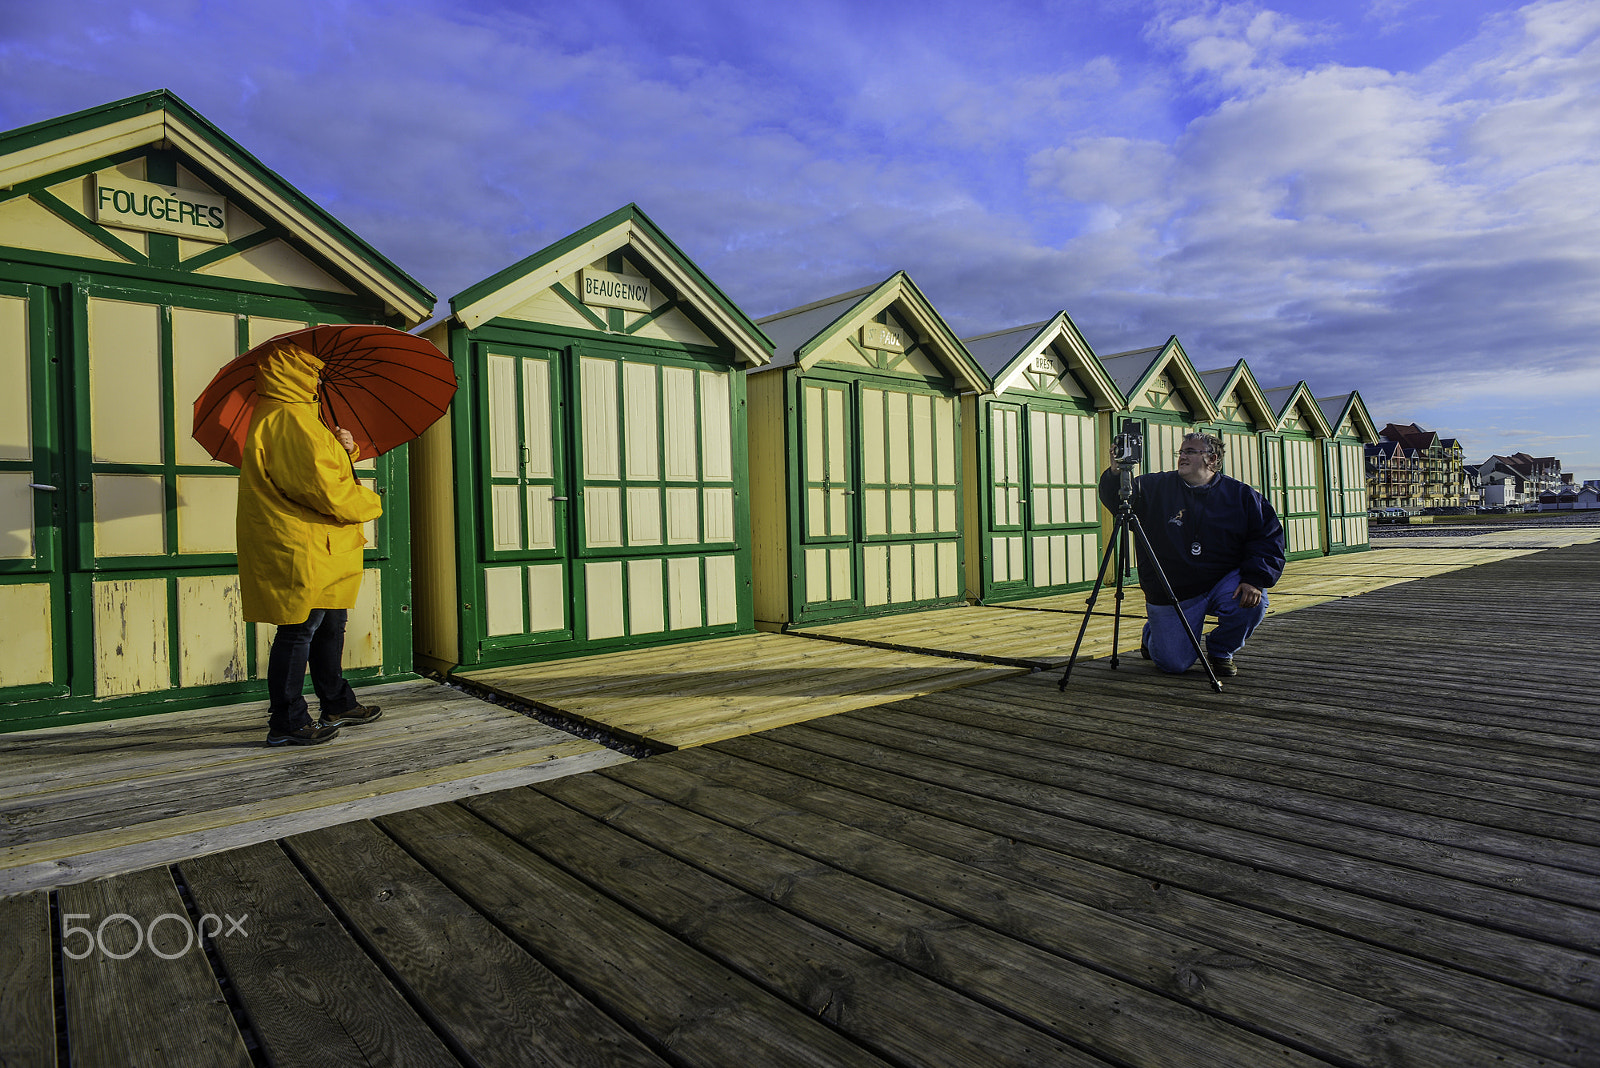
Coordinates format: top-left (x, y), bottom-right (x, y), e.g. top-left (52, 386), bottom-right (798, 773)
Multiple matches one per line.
top-left (0, 545), bottom-right (1600, 1068)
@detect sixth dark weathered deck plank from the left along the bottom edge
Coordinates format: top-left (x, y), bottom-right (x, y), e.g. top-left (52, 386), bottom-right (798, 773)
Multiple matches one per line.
top-left (467, 790), bottom-right (1106, 1068)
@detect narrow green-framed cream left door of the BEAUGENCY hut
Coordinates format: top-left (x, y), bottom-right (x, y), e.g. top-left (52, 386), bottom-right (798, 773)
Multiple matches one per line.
top-left (477, 344), bottom-right (573, 649)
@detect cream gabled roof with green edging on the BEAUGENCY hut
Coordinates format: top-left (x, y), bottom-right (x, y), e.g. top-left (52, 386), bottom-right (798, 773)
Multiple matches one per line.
top-left (450, 205), bottom-right (773, 366)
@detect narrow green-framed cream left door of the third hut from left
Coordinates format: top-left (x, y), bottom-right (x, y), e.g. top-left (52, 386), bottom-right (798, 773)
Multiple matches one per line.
top-left (800, 379), bottom-right (882, 611)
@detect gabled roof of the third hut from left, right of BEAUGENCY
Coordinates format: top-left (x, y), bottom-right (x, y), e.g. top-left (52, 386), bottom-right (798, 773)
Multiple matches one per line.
top-left (757, 270), bottom-right (990, 393)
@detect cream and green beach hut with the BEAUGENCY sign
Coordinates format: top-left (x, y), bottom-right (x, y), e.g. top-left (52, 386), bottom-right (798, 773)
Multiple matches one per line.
top-left (413, 205), bottom-right (771, 670)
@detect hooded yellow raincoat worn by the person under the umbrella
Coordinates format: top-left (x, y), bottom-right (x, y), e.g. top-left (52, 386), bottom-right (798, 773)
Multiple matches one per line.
top-left (237, 345), bottom-right (384, 625)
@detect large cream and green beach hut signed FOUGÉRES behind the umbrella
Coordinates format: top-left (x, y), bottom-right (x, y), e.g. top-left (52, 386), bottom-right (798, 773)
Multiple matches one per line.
top-left (0, 91), bottom-right (434, 729)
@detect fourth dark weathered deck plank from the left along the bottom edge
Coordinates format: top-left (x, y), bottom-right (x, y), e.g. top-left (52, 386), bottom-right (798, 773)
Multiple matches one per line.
top-left (283, 820), bottom-right (664, 1068)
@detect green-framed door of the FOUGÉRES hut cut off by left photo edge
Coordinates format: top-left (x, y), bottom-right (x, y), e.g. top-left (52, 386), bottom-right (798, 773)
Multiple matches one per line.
top-left (0, 281), bottom-right (72, 707)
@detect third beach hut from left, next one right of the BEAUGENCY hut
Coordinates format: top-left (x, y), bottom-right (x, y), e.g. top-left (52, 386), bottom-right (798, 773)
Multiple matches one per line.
top-left (747, 272), bottom-right (989, 630)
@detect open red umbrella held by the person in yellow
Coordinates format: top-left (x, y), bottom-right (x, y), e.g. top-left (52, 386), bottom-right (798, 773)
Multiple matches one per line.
top-left (194, 323), bottom-right (456, 467)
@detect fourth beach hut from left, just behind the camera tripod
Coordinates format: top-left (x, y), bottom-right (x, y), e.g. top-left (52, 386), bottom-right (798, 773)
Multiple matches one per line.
top-left (962, 312), bottom-right (1123, 601)
